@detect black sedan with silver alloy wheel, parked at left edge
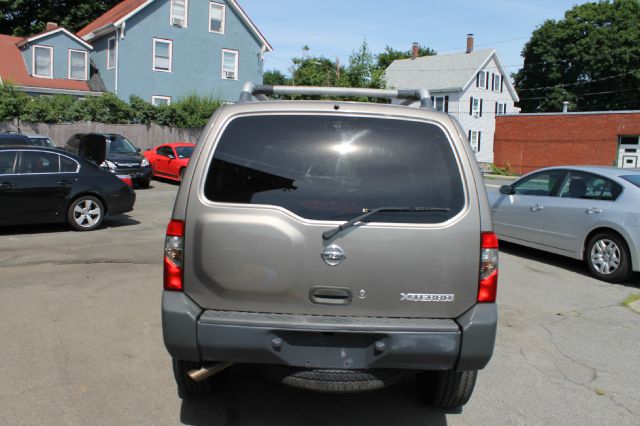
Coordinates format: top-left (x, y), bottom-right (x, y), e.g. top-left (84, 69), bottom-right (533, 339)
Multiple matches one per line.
top-left (0, 147), bottom-right (136, 231)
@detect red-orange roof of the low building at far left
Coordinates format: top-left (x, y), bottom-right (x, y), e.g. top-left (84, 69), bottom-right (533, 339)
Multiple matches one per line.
top-left (0, 35), bottom-right (91, 92)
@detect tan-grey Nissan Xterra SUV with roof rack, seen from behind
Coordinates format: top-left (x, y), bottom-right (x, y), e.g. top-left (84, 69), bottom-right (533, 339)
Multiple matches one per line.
top-left (162, 83), bottom-right (498, 408)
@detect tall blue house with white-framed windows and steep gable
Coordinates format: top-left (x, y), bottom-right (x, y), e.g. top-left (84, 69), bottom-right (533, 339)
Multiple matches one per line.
top-left (77, 0), bottom-right (272, 105)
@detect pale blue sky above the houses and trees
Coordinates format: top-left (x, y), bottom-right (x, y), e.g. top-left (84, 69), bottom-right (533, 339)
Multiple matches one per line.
top-left (239, 0), bottom-right (586, 74)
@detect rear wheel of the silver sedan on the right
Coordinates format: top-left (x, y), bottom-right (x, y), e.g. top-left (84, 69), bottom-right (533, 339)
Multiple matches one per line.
top-left (584, 232), bottom-right (633, 283)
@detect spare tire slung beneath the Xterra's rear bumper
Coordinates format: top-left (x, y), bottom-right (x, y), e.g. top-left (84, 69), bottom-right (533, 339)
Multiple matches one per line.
top-left (264, 365), bottom-right (404, 393)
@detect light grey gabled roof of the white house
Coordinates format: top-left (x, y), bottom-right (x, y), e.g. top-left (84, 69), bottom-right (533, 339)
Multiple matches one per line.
top-left (385, 49), bottom-right (518, 102)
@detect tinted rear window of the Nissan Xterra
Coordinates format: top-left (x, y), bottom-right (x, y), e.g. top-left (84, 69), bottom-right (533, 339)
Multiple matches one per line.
top-left (204, 115), bottom-right (464, 223)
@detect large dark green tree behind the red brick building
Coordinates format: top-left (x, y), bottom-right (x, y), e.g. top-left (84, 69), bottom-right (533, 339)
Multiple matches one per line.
top-left (515, 0), bottom-right (640, 112)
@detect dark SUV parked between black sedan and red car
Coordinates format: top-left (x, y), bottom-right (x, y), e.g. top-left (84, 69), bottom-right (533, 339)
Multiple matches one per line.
top-left (65, 133), bottom-right (151, 188)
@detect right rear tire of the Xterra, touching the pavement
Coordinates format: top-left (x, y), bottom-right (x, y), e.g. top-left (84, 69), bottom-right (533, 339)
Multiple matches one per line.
top-left (416, 370), bottom-right (478, 409)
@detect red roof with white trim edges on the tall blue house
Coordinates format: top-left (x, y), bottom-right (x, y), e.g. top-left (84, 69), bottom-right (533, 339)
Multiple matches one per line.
top-left (77, 0), bottom-right (273, 52)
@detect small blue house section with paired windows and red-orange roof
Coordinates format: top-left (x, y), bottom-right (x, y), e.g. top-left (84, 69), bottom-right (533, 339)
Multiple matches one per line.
top-left (0, 23), bottom-right (104, 97)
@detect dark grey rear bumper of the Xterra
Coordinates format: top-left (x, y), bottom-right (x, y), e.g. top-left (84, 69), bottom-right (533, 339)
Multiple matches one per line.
top-left (162, 291), bottom-right (497, 370)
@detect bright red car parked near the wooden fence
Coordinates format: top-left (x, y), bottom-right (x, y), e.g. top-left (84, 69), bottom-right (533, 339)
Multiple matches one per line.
top-left (144, 142), bottom-right (196, 181)
